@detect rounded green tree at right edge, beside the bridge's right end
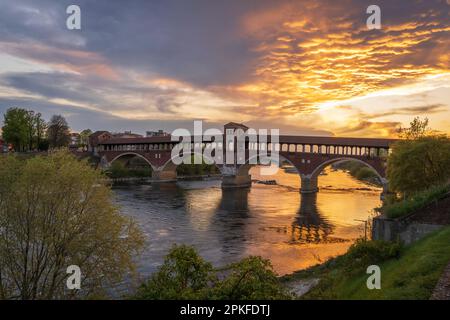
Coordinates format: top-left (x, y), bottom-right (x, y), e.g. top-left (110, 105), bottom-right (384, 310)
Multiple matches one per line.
top-left (387, 135), bottom-right (450, 196)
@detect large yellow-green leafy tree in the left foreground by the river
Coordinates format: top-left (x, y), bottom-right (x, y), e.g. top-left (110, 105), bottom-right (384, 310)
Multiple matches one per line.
top-left (0, 151), bottom-right (143, 299)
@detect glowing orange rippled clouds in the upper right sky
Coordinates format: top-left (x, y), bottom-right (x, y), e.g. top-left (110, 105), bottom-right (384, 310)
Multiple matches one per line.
top-left (211, 1), bottom-right (450, 135)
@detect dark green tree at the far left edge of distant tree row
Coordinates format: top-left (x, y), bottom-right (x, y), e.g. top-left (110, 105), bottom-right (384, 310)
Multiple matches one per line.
top-left (2, 108), bottom-right (29, 151)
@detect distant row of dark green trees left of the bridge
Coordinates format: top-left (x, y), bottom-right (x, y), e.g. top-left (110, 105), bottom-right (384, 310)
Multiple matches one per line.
top-left (2, 108), bottom-right (92, 152)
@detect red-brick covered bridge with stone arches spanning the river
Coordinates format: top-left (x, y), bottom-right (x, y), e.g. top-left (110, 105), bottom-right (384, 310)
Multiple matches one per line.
top-left (94, 123), bottom-right (395, 193)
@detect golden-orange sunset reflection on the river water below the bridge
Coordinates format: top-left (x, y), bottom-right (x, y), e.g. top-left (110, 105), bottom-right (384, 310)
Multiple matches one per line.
top-left (181, 167), bottom-right (381, 274)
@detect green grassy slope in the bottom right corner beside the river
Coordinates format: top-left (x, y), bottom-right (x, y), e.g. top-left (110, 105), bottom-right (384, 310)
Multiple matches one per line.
top-left (283, 227), bottom-right (450, 299)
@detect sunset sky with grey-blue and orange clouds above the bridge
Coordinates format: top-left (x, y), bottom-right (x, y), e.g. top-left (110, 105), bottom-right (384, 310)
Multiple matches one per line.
top-left (0, 0), bottom-right (450, 137)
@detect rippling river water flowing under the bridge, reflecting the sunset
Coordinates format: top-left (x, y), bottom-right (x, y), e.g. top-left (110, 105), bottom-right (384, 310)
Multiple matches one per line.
top-left (114, 168), bottom-right (381, 276)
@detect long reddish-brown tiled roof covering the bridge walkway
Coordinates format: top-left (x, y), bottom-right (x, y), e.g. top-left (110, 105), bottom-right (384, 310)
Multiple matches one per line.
top-left (99, 135), bottom-right (397, 148)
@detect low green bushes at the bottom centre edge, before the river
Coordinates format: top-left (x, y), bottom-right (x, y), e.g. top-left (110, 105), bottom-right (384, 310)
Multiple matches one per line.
top-left (135, 245), bottom-right (290, 300)
